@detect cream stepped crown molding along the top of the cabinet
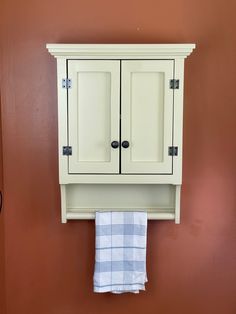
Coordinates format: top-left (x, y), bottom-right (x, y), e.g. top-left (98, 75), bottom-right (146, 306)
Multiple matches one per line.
top-left (46, 44), bottom-right (196, 59)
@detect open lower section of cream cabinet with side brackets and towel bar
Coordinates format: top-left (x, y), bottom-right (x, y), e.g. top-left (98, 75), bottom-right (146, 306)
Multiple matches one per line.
top-left (60, 184), bottom-right (181, 224)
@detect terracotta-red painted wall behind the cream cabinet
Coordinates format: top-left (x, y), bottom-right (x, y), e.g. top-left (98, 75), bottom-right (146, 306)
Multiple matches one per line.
top-left (0, 0), bottom-right (236, 314)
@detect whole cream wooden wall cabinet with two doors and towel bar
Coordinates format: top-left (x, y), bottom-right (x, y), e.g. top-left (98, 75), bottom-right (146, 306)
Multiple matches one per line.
top-left (47, 44), bottom-right (195, 223)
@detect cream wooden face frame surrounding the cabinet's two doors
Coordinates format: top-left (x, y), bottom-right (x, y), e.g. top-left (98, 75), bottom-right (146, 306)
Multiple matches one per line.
top-left (57, 57), bottom-right (184, 184)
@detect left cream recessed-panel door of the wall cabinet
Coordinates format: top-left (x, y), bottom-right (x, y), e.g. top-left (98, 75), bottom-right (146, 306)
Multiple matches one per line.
top-left (68, 60), bottom-right (120, 173)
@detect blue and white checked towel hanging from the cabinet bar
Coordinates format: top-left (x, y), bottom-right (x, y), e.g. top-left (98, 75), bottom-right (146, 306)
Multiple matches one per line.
top-left (94, 212), bottom-right (147, 293)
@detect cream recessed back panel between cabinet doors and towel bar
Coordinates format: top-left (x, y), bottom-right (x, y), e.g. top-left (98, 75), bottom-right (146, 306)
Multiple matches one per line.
top-left (67, 184), bottom-right (175, 210)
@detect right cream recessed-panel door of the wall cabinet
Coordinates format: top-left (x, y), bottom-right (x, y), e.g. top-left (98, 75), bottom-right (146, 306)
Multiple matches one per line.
top-left (121, 60), bottom-right (174, 174)
